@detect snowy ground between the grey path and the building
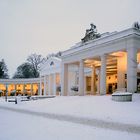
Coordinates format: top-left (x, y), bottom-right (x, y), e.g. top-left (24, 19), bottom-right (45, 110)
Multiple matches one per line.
top-left (0, 94), bottom-right (140, 125)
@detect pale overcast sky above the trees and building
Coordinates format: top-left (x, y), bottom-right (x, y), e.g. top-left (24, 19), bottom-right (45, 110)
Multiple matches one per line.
top-left (0, 0), bottom-right (140, 77)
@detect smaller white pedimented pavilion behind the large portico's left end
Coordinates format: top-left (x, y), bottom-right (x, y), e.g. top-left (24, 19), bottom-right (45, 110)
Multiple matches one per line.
top-left (40, 57), bottom-right (85, 95)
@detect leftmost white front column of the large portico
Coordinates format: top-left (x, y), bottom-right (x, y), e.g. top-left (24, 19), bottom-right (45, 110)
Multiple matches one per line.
top-left (61, 63), bottom-right (68, 96)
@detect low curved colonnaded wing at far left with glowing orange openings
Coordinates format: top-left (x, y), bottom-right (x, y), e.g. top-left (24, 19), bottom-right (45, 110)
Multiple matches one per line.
top-left (0, 78), bottom-right (40, 96)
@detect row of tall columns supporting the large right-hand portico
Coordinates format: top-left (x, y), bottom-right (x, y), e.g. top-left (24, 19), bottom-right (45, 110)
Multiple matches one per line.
top-left (61, 46), bottom-right (138, 96)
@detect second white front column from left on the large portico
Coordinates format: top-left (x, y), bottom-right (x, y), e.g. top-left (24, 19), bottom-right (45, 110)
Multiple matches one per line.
top-left (79, 60), bottom-right (85, 96)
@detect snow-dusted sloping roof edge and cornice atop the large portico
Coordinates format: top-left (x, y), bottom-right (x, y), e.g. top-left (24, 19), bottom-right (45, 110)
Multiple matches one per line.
top-left (61, 28), bottom-right (140, 59)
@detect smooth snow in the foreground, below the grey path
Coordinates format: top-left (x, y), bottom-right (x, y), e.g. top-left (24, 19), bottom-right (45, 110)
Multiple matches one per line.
top-left (0, 109), bottom-right (140, 140)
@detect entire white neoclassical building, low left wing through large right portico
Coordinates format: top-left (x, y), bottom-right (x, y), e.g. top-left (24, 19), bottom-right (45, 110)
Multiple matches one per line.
top-left (0, 24), bottom-right (140, 96)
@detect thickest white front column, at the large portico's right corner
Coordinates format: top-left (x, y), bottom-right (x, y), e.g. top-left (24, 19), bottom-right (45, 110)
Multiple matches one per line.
top-left (127, 47), bottom-right (137, 93)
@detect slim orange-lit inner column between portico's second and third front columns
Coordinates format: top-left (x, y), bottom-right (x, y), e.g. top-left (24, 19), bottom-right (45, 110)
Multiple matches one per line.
top-left (91, 66), bottom-right (95, 94)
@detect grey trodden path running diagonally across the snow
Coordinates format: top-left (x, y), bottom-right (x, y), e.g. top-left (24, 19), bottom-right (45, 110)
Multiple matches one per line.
top-left (0, 106), bottom-right (140, 134)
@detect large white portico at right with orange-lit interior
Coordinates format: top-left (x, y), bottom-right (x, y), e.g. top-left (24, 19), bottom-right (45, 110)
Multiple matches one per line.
top-left (61, 24), bottom-right (140, 95)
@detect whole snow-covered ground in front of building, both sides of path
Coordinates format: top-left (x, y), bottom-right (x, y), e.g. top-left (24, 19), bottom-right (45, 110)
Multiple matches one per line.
top-left (0, 94), bottom-right (140, 140)
